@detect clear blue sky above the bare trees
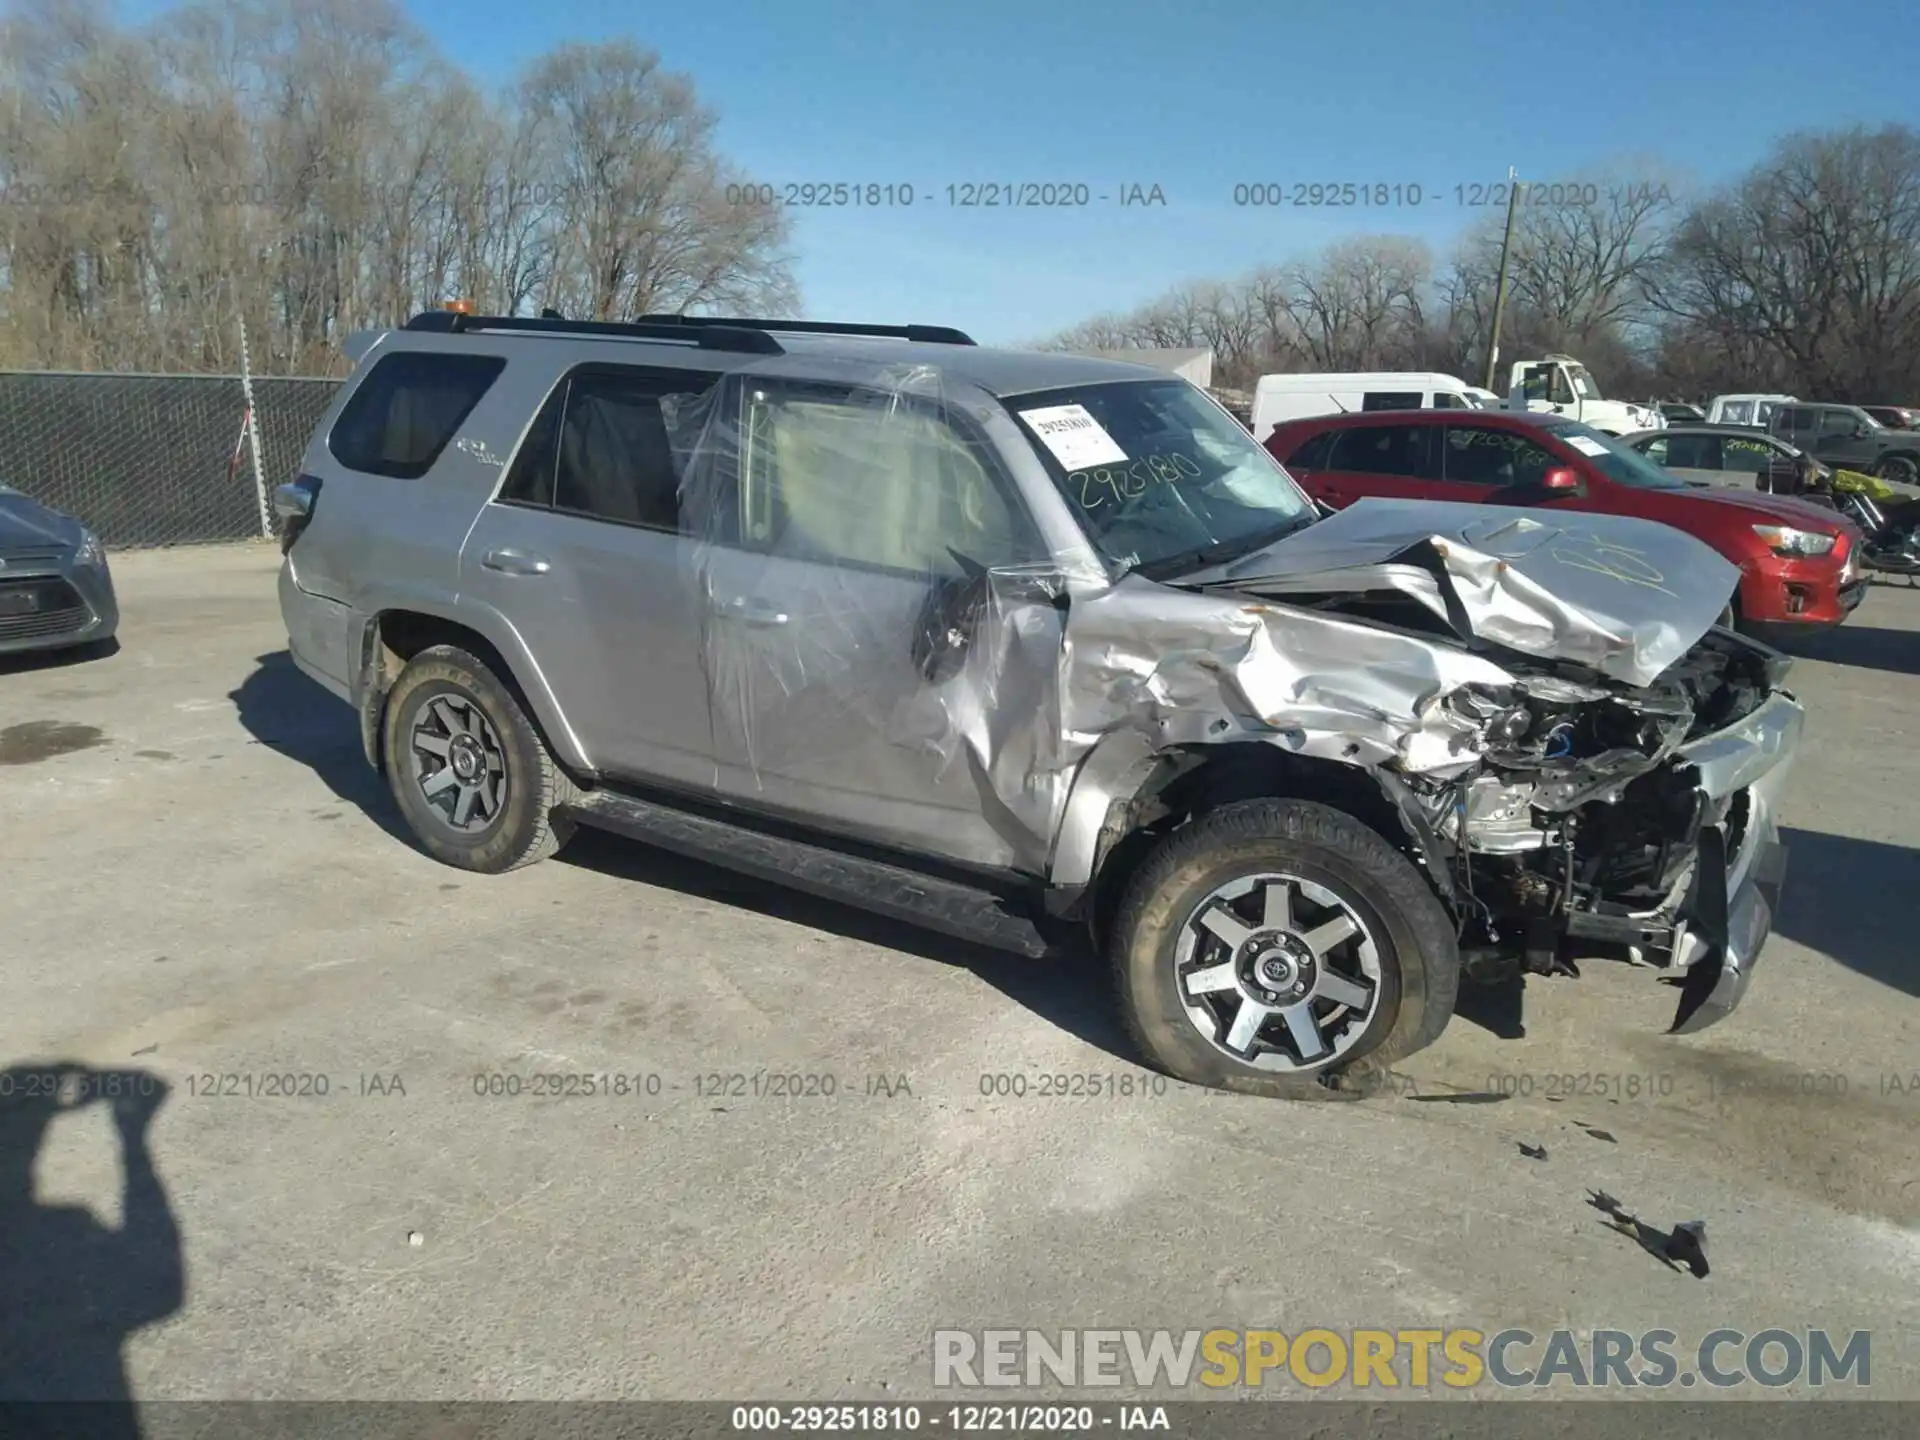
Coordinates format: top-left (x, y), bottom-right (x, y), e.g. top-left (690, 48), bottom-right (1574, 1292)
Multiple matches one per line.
top-left (136, 0), bottom-right (1920, 342)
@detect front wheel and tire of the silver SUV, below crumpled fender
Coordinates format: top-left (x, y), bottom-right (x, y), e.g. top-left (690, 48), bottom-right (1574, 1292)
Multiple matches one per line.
top-left (1112, 799), bottom-right (1459, 1100)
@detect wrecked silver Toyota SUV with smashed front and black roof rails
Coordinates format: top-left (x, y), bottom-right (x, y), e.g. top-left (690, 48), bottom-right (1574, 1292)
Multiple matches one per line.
top-left (276, 309), bottom-right (1803, 1096)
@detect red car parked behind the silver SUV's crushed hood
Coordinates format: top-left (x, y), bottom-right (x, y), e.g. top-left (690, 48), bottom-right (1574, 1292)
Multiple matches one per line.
top-left (1267, 411), bottom-right (1866, 639)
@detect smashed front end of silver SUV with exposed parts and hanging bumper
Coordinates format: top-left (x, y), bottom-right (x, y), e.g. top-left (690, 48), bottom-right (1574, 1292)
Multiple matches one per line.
top-left (1413, 632), bottom-right (1805, 1031)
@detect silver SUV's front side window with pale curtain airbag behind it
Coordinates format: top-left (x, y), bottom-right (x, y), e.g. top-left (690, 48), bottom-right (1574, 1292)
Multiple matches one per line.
top-left (737, 386), bottom-right (1036, 578)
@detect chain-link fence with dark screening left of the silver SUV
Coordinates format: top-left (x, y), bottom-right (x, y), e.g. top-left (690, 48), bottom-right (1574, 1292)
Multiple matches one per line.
top-left (0, 371), bottom-right (340, 545)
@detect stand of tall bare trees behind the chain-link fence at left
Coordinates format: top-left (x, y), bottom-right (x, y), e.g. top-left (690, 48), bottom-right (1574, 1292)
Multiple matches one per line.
top-left (0, 0), bottom-right (797, 371)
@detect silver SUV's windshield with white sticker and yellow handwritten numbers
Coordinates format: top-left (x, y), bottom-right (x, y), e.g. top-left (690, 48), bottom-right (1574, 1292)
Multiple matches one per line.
top-left (1004, 380), bottom-right (1313, 576)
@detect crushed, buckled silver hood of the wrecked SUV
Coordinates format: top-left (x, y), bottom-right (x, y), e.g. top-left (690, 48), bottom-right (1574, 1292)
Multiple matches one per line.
top-left (1181, 499), bottom-right (1740, 685)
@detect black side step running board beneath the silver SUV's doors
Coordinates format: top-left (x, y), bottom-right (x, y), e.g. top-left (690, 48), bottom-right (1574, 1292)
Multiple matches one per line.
top-left (566, 789), bottom-right (1052, 958)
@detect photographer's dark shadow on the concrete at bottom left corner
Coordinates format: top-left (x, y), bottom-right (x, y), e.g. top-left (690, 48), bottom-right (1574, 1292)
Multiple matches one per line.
top-left (0, 1064), bottom-right (184, 1436)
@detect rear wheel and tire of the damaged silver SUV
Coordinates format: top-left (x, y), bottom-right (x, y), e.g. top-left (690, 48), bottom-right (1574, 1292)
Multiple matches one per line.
top-left (382, 645), bottom-right (574, 876)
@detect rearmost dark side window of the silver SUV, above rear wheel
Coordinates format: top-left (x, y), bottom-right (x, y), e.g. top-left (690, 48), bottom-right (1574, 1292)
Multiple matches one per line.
top-left (326, 349), bottom-right (507, 480)
